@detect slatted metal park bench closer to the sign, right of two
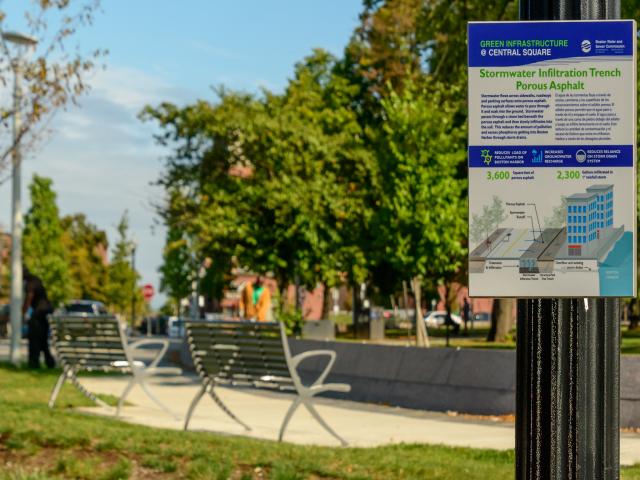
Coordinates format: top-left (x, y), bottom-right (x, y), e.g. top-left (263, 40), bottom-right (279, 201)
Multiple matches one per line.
top-left (184, 321), bottom-right (351, 445)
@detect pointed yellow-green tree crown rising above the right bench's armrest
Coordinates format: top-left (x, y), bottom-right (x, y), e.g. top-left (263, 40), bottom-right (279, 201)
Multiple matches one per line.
top-left (239, 50), bottom-right (375, 287)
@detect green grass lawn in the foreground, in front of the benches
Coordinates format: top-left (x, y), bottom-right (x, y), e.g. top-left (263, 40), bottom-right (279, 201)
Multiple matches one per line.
top-left (0, 366), bottom-right (640, 480)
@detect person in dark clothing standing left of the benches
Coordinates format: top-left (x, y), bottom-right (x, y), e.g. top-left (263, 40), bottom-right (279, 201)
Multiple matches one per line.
top-left (22, 267), bottom-right (55, 368)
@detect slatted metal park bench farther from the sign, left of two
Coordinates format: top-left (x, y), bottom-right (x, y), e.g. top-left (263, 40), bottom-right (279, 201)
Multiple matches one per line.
top-left (49, 313), bottom-right (182, 418)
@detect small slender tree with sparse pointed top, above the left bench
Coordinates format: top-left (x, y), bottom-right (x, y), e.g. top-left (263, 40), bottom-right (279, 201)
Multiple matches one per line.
top-left (104, 211), bottom-right (144, 321)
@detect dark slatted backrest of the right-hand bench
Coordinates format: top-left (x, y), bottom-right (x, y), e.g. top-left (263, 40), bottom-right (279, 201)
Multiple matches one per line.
top-left (186, 321), bottom-right (293, 390)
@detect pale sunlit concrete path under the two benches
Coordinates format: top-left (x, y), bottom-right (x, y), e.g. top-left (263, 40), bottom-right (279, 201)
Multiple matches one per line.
top-left (72, 377), bottom-right (640, 465)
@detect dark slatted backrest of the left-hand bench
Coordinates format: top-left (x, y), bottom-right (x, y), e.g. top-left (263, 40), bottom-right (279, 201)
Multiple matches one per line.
top-left (50, 313), bottom-right (127, 370)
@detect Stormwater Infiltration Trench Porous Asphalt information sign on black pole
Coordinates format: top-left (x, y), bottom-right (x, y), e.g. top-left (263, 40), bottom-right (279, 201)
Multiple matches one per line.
top-left (469, 20), bottom-right (637, 297)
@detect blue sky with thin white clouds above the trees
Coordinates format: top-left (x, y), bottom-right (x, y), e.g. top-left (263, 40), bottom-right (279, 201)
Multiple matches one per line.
top-left (0, 0), bottom-right (361, 306)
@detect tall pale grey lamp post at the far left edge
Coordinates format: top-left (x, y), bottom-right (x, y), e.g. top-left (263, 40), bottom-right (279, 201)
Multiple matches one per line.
top-left (2, 32), bottom-right (38, 365)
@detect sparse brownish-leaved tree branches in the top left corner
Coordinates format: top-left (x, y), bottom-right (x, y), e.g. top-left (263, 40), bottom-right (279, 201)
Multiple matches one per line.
top-left (0, 0), bottom-right (106, 171)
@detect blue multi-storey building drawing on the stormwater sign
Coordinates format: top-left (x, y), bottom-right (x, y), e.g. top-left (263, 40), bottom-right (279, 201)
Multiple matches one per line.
top-left (567, 185), bottom-right (613, 256)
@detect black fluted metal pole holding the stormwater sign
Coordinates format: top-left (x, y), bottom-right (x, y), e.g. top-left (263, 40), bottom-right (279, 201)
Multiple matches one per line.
top-left (516, 0), bottom-right (620, 480)
